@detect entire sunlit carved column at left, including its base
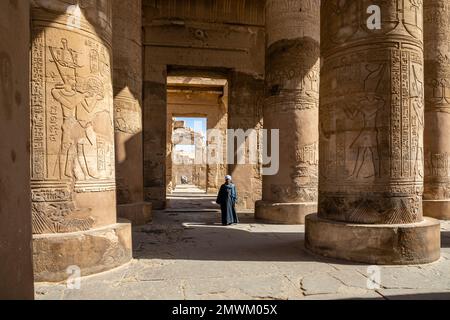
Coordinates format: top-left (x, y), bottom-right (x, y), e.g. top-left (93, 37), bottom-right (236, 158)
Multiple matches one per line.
top-left (31, 0), bottom-right (131, 281)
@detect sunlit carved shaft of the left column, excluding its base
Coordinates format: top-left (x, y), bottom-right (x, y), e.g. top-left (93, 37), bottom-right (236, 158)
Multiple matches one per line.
top-left (30, 0), bottom-right (115, 233)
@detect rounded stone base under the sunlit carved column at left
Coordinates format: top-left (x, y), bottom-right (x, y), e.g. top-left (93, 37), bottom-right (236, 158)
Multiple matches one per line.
top-left (33, 222), bottom-right (133, 282)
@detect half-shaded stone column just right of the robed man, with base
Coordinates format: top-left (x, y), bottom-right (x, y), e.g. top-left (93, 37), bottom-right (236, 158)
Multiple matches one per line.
top-left (256, 0), bottom-right (320, 224)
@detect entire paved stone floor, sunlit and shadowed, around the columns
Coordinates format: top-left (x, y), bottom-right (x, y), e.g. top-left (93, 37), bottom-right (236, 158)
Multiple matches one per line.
top-left (36, 186), bottom-right (450, 300)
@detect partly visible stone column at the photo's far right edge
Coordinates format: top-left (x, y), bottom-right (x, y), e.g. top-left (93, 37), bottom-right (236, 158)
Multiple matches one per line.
top-left (423, 0), bottom-right (450, 219)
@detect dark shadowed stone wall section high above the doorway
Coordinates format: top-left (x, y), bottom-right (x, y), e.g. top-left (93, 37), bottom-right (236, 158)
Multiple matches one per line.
top-left (143, 0), bottom-right (265, 74)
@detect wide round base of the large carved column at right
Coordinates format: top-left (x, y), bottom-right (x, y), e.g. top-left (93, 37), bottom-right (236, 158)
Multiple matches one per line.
top-left (305, 214), bottom-right (441, 265)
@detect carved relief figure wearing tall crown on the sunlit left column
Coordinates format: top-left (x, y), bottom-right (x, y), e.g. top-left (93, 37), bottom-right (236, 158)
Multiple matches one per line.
top-left (50, 39), bottom-right (104, 180)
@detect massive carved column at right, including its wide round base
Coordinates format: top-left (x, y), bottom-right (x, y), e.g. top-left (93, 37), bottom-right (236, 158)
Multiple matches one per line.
top-left (305, 0), bottom-right (440, 264)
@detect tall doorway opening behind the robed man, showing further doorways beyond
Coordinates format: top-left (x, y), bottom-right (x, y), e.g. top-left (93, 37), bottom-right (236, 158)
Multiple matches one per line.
top-left (166, 74), bottom-right (228, 211)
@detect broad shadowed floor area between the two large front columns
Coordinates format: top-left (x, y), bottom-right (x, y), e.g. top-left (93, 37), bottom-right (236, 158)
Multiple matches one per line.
top-left (133, 211), bottom-right (364, 265)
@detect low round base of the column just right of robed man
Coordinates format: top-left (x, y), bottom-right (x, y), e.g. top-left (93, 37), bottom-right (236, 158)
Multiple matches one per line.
top-left (255, 201), bottom-right (317, 224)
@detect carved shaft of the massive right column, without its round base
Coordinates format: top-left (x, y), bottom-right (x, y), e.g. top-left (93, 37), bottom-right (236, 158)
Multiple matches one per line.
top-left (319, 0), bottom-right (424, 224)
